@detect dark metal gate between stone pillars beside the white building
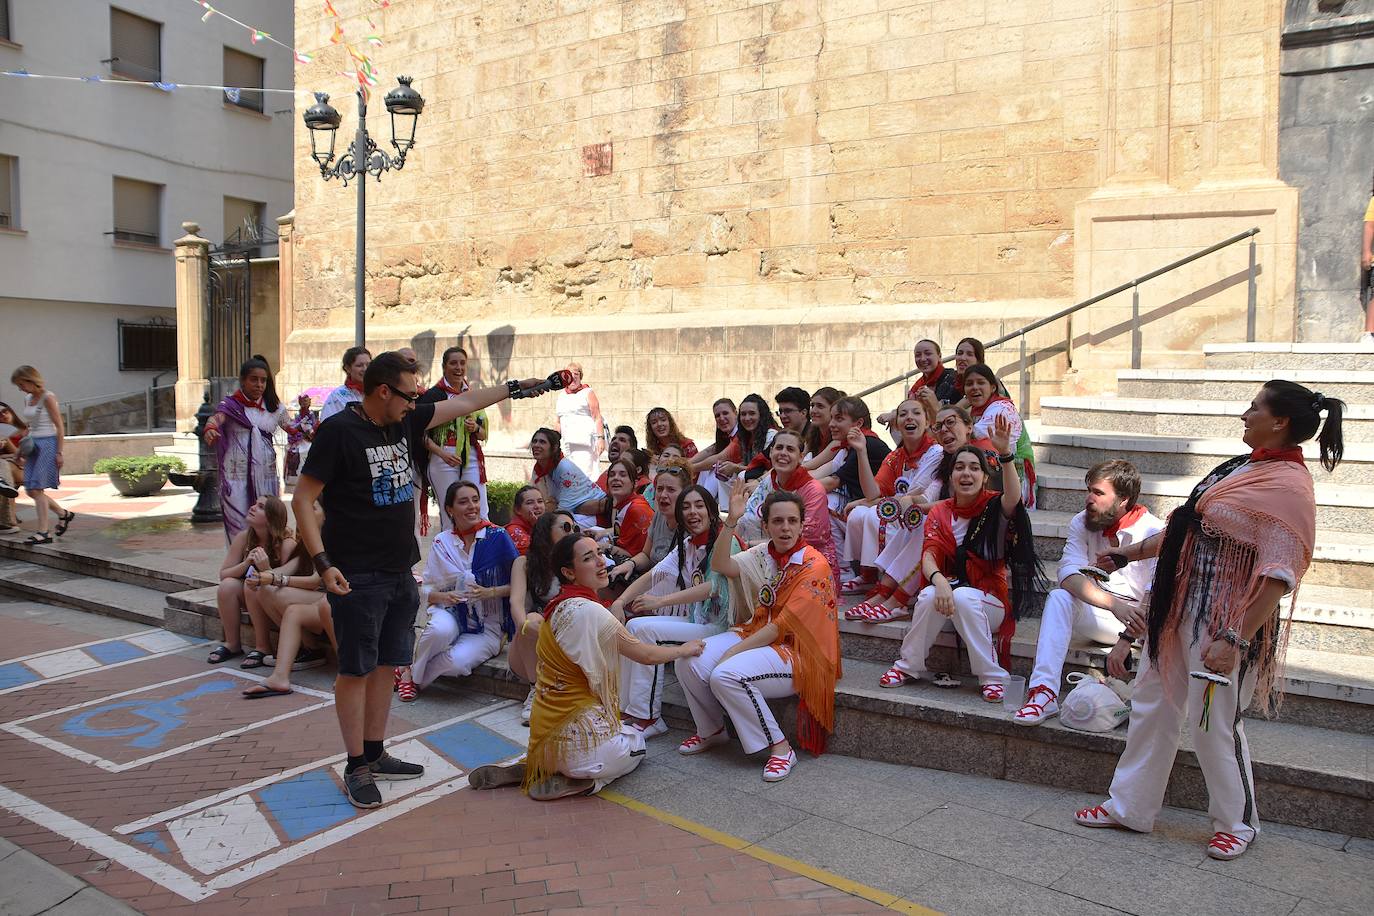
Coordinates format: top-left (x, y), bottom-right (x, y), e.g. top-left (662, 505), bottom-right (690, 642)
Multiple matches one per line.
top-left (207, 222), bottom-right (276, 397)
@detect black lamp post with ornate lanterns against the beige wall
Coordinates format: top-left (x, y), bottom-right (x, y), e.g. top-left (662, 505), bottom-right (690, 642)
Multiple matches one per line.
top-left (304, 77), bottom-right (425, 346)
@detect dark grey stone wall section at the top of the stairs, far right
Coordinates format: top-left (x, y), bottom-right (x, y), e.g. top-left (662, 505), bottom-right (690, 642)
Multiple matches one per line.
top-left (1279, 0), bottom-right (1374, 341)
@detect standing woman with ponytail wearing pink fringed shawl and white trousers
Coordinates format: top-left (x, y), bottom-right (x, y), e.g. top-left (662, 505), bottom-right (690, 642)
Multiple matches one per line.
top-left (1074, 380), bottom-right (1344, 860)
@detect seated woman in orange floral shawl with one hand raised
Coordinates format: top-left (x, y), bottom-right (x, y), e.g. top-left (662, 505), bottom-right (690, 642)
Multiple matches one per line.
top-left (676, 481), bottom-right (841, 783)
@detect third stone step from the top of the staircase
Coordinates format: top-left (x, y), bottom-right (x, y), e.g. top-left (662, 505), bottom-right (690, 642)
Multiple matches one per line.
top-left (1040, 397), bottom-right (1374, 442)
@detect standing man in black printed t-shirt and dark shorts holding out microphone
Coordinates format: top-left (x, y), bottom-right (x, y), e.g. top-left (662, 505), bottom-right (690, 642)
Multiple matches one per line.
top-left (291, 353), bottom-right (563, 808)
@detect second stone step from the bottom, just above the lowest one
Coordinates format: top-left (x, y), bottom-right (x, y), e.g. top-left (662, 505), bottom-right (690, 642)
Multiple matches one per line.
top-left (840, 618), bottom-right (1374, 735)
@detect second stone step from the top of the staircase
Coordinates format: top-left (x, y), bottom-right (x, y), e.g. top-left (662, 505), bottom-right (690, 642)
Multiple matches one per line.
top-left (1117, 368), bottom-right (1374, 404)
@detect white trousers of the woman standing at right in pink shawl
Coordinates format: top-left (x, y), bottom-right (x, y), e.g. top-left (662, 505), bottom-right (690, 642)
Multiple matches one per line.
top-left (1102, 615), bottom-right (1260, 840)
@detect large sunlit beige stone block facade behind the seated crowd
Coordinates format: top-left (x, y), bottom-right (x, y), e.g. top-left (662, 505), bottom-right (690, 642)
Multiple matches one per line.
top-left (282, 0), bottom-right (1297, 435)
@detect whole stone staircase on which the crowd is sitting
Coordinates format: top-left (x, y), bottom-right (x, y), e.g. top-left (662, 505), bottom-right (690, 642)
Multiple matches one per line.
top-left (0, 345), bottom-right (1374, 836)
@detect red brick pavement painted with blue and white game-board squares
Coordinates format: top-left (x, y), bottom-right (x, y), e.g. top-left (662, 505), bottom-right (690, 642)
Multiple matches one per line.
top-left (0, 602), bottom-right (879, 916)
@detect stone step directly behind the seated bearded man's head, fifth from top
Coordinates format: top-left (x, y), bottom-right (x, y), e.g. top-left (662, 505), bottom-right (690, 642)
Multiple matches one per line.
top-left (1036, 463), bottom-right (1374, 531)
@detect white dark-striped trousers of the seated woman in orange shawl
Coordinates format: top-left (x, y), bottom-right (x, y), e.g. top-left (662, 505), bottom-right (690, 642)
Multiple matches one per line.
top-left (673, 630), bottom-right (797, 754)
